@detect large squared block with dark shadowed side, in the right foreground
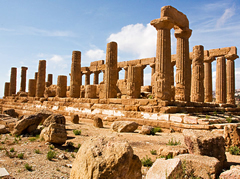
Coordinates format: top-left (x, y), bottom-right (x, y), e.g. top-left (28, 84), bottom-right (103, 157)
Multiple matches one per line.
top-left (183, 129), bottom-right (227, 166)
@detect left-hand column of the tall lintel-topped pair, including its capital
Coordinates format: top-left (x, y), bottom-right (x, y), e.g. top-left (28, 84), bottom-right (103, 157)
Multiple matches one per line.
top-left (151, 17), bottom-right (174, 101)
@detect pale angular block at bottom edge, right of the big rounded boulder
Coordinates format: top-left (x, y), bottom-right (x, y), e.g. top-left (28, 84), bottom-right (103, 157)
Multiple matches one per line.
top-left (146, 158), bottom-right (183, 179)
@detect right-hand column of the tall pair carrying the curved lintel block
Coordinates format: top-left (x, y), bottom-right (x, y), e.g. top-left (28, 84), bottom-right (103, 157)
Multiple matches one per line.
top-left (175, 28), bottom-right (192, 101)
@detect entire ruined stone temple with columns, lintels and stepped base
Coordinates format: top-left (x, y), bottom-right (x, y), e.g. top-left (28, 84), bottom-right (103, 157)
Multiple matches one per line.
top-left (2, 6), bottom-right (239, 129)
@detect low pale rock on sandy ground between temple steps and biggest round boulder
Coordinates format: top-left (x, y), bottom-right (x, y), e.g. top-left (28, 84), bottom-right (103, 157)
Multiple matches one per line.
top-left (111, 121), bottom-right (138, 132)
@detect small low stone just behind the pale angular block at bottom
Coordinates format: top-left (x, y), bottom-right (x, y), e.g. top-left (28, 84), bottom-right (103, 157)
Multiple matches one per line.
top-left (159, 145), bottom-right (188, 157)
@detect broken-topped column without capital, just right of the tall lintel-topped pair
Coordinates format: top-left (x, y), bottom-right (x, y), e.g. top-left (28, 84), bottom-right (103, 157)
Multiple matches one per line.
top-left (191, 45), bottom-right (204, 102)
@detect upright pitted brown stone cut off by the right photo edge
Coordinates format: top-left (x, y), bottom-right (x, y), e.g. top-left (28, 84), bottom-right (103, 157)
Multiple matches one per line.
top-left (224, 124), bottom-right (240, 150)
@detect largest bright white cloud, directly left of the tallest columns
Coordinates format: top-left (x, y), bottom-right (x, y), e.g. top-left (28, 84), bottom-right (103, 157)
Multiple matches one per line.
top-left (107, 23), bottom-right (157, 58)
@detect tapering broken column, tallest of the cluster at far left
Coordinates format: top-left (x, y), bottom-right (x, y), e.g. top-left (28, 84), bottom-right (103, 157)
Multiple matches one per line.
top-left (36, 60), bottom-right (46, 97)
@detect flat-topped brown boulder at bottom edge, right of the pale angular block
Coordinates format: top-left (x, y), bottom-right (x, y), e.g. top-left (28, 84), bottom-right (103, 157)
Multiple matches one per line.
top-left (175, 154), bottom-right (222, 179)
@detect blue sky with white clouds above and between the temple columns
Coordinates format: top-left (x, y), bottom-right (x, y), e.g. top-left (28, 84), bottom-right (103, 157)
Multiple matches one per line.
top-left (0, 0), bottom-right (240, 97)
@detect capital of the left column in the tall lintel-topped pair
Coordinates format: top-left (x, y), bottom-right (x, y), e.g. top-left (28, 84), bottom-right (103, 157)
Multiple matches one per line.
top-left (150, 17), bottom-right (174, 30)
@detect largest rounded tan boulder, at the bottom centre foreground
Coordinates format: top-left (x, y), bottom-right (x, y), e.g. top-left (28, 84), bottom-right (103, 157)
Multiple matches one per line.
top-left (70, 136), bottom-right (142, 179)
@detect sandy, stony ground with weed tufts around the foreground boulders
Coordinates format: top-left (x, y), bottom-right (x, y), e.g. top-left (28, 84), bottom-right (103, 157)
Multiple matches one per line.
top-left (0, 118), bottom-right (240, 179)
